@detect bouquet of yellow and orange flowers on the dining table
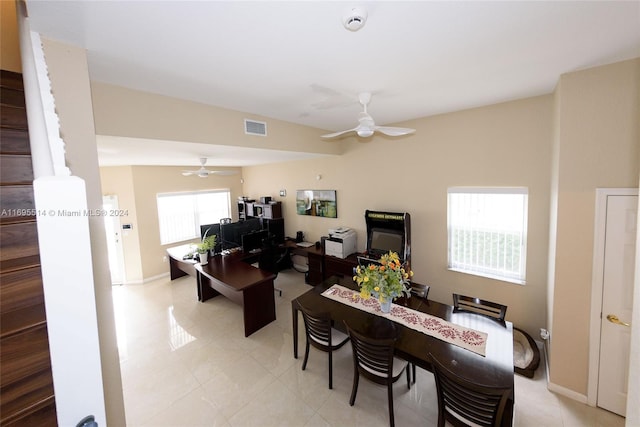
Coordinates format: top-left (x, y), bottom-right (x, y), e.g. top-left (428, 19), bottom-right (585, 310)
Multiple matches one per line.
top-left (353, 252), bottom-right (413, 303)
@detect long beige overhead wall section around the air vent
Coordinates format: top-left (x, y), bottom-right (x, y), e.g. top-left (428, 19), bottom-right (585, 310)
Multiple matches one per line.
top-left (92, 82), bottom-right (341, 154)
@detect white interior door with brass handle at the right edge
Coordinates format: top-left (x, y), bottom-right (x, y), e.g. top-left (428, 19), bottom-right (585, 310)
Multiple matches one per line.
top-left (597, 195), bottom-right (638, 416)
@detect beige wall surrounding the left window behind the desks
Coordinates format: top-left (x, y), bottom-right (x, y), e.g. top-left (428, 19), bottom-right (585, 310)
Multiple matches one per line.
top-left (100, 166), bottom-right (242, 283)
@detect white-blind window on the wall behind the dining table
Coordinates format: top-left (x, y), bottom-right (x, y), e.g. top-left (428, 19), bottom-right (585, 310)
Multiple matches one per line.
top-left (447, 187), bottom-right (528, 284)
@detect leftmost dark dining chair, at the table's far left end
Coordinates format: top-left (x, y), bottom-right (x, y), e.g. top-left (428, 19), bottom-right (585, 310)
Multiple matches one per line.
top-left (300, 305), bottom-right (349, 389)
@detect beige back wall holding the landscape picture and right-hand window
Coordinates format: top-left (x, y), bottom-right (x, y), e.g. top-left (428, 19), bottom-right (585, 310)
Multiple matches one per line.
top-left (244, 95), bottom-right (553, 336)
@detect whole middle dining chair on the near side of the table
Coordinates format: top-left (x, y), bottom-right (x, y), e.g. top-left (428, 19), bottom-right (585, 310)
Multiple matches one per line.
top-left (344, 321), bottom-right (411, 427)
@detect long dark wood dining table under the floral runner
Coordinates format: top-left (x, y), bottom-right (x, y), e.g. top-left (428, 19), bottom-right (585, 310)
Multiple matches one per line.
top-left (291, 277), bottom-right (515, 426)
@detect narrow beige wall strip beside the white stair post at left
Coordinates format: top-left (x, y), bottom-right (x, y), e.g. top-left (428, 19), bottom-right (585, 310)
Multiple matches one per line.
top-left (42, 39), bottom-right (125, 425)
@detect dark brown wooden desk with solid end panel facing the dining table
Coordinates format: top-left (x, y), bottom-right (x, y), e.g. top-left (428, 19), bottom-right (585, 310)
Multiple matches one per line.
top-left (195, 253), bottom-right (276, 337)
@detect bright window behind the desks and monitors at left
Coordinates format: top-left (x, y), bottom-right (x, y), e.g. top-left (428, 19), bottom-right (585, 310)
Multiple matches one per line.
top-left (156, 190), bottom-right (231, 245)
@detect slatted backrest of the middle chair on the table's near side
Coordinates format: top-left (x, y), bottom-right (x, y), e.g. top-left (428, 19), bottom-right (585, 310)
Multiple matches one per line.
top-left (344, 322), bottom-right (396, 384)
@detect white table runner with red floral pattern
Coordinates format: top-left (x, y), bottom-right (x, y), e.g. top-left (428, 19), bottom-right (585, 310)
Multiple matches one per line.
top-left (322, 285), bottom-right (487, 356)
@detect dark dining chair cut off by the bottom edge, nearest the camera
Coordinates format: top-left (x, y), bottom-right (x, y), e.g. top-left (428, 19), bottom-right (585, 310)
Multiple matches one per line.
top-left (429, 353), bottom-right (511, 427)
